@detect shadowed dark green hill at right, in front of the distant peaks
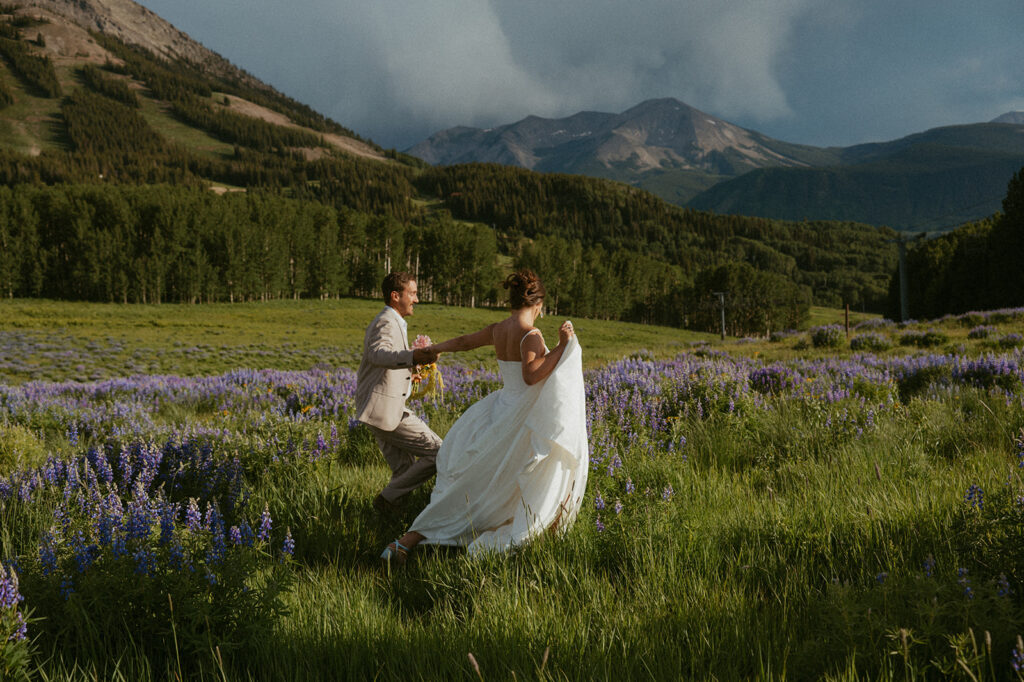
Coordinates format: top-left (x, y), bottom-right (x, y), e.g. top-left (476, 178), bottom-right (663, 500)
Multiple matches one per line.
top-left (687, 123), bottom-right (1024, 231)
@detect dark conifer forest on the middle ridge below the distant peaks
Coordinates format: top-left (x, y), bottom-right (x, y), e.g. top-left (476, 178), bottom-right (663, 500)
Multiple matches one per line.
top-left (416, 164), bottom-right (896, 311)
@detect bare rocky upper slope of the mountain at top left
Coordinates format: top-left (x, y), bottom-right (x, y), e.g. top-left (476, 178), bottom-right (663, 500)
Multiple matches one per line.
top-left (0, 0), bottom-right (386, 161)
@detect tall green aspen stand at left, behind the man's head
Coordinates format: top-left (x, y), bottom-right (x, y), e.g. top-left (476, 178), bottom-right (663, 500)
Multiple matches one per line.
top-left (0, 185), bottom-right (498, 305)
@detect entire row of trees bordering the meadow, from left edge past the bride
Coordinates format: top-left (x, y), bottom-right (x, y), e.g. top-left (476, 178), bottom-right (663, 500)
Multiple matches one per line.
top-left (0, 178), bottom-right (810, 334)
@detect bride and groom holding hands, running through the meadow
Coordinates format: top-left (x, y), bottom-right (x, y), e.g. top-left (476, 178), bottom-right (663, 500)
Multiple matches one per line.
top-left (355, 270), bottom-right (590, 567)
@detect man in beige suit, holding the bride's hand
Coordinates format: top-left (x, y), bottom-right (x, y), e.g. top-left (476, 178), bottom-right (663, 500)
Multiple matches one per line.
top-left (355, 272), bottom-right (441, 512)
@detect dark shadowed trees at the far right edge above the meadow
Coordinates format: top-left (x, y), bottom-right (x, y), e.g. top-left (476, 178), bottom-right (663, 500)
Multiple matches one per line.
top-left (887, 169), bottom-right (1024, 319)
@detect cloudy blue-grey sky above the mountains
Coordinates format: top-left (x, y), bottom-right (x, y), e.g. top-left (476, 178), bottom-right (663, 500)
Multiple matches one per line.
top-left (140, 0), bottom-right (1024, 150)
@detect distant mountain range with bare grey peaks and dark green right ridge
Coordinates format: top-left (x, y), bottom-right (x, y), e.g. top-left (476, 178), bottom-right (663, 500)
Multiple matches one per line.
top-left (408, 98), bottom-right (1024, 230)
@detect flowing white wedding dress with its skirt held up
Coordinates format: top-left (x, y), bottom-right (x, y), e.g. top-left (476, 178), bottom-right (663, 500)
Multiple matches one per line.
top-left (410, 332), bottom-right (590, 554)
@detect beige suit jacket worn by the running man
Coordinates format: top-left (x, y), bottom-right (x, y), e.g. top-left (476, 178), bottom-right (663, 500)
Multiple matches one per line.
top-left (355, 306), bottom-right (413, 431)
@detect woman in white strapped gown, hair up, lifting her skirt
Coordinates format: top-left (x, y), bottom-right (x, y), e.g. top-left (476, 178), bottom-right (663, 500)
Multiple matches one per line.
top-left (381, 270), bottom-right (590, 567)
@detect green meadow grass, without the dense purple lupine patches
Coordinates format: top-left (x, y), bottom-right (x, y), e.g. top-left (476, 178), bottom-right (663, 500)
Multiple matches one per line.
top-left (0, 300), bottom-right (1024, 680)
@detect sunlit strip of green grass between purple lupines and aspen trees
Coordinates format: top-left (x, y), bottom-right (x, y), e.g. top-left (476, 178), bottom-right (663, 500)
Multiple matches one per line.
top-left (0, 299), bottom-right (713, 382)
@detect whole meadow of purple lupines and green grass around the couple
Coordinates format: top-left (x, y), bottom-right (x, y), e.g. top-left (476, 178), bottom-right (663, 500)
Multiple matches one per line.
top-left (0, 303), bottom-right (1024, 680)
